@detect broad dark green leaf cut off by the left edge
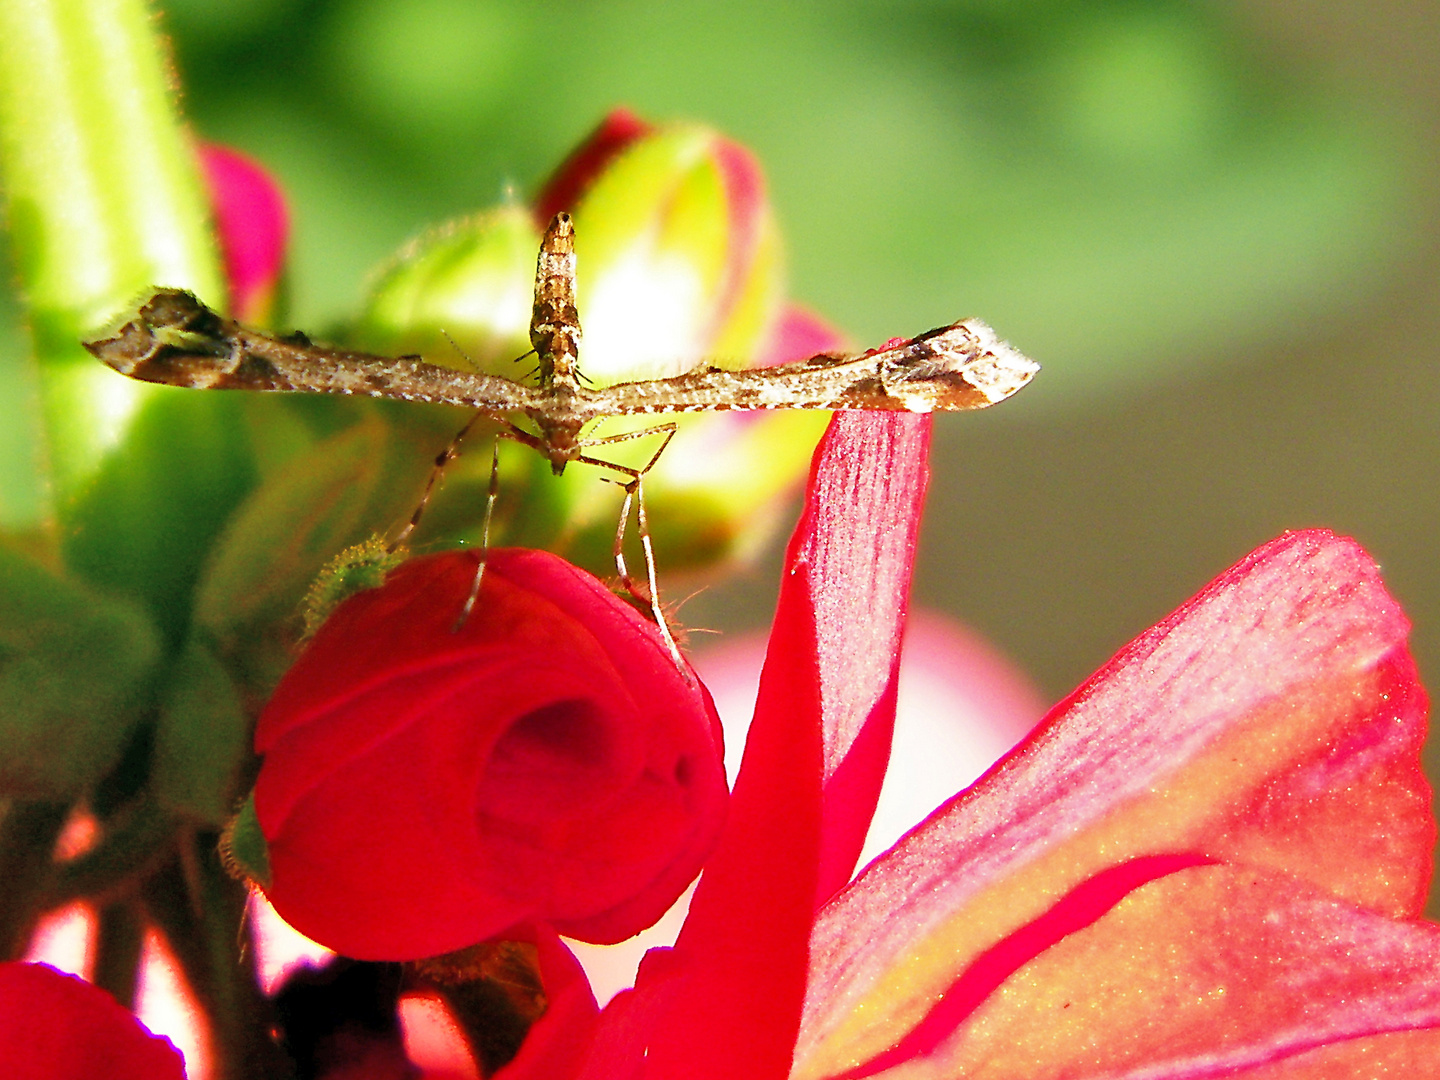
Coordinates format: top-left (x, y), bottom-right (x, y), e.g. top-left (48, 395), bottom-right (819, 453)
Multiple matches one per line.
top-left (0, 547), bottom-right (161, 796)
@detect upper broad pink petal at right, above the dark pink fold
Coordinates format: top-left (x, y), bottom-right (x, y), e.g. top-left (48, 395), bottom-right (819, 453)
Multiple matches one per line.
top-left (801, 533), bottom-right (1433, 1073)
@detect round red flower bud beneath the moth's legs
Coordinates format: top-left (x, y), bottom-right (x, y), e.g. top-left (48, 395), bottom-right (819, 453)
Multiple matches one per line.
top-left (255, 549), bottom-right (727, 959)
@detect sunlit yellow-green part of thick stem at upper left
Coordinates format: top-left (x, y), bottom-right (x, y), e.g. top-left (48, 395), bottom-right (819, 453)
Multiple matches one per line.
top-left (0, 0), bottom-right (223, 507)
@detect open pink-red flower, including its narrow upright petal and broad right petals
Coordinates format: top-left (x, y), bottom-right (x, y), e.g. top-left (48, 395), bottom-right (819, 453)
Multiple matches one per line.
top-left (480, 415), bottom-right (1440, 1080)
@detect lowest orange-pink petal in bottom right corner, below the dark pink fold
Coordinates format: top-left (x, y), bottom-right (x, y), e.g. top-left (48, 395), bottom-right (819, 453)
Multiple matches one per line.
top-left (881, 865), bottom-right (1440, 1080)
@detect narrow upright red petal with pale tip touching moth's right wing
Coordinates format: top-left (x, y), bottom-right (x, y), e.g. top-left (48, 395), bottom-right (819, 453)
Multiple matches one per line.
top-left (585, 412), bottom-right (930, 1080)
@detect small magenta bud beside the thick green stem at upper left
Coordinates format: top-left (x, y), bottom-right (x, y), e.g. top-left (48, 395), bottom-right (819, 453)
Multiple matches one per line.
top-left (199, 143), bottom-right (289, 323)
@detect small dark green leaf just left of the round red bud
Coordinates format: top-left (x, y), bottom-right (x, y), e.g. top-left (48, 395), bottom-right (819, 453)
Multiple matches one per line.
top-left (150, 639), bottom-right (251, 828)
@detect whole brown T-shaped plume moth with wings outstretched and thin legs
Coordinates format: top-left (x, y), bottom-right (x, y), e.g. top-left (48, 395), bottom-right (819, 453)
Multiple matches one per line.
top-left (85, 213), bottom-right (1040, 667)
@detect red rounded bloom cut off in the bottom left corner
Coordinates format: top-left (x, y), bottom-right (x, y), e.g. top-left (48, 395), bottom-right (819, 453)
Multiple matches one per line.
top-left (0, 963), bottom-right (184, 1080)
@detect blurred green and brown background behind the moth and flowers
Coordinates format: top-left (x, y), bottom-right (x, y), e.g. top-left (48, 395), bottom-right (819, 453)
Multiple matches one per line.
top-left (0, 0), bottom-right (1440, 864)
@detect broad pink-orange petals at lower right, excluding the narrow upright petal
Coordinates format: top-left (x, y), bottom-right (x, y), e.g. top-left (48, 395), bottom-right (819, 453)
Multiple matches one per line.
top-left (798, 531), bottom-right (1440, 1077)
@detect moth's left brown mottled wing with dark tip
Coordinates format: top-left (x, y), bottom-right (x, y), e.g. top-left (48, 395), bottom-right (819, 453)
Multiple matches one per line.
top-left (85, 289), bottom-right (541, 418)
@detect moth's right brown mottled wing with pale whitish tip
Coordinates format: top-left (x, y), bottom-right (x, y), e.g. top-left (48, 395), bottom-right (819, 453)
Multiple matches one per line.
top-left (582, 318), bottom-right (1040, 416)
